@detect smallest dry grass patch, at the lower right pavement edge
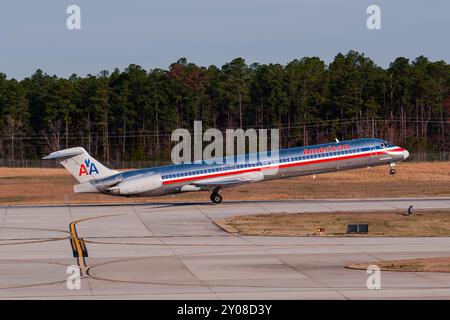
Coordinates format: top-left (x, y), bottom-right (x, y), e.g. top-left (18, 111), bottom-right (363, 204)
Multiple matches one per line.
top-left (347, 257), bottom-right (450, 272)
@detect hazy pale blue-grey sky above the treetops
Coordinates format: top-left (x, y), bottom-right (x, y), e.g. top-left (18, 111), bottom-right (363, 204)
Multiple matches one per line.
top-left (0, 0), bottom-right (450, 79)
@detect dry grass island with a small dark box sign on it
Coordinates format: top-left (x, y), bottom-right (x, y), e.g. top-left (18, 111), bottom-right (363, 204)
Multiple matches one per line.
top-left (216, 210), bottom-right (450, 237)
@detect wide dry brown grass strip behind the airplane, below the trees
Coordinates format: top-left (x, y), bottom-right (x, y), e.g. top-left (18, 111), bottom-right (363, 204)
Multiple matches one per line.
top-left (0, 162), bottom-right (450, 204)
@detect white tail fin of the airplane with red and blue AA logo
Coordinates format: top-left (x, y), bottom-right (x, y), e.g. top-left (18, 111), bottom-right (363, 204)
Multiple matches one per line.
top-left (42, 147), bottom-right (119, 192)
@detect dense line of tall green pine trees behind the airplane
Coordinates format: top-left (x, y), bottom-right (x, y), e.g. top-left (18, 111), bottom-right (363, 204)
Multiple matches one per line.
top-left (0, 51), bottom-right (450, 162)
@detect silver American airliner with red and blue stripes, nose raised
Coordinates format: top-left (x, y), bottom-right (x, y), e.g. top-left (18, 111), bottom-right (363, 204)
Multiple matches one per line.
top-left (43, 138), bottom-right (409, 204)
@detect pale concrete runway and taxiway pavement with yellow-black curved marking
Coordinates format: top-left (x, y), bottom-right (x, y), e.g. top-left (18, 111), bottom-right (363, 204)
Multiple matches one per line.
top-left (0, 198), bottom-right (450, 299)
